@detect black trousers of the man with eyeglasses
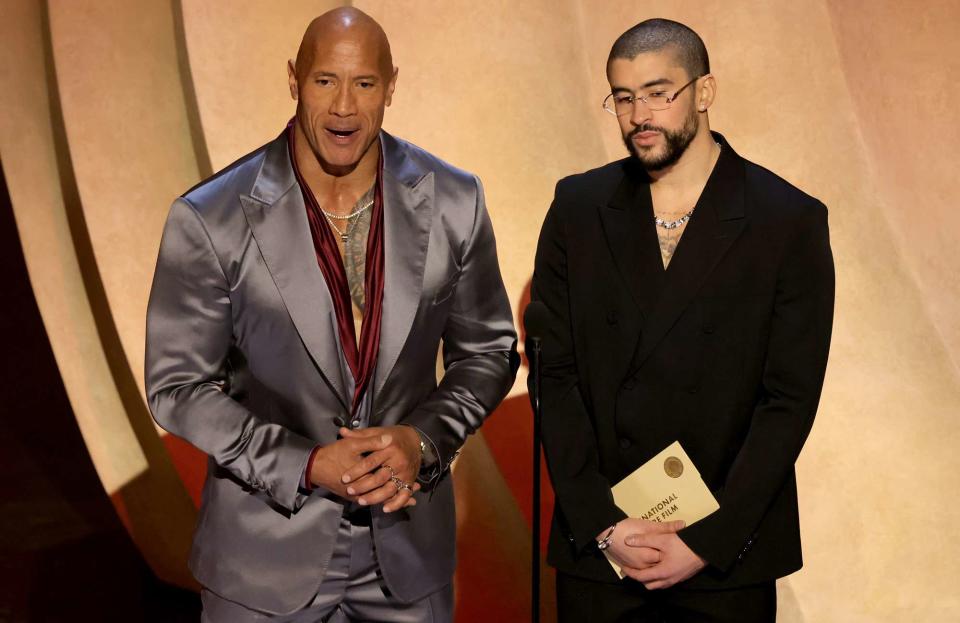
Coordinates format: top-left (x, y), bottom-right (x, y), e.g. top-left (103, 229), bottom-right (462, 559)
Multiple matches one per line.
top-left (557, 572), bottom-right (777, 623)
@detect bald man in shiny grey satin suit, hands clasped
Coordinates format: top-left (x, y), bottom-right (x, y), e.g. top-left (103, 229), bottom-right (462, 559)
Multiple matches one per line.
top-left (146, 8), bottom-right (516, 623)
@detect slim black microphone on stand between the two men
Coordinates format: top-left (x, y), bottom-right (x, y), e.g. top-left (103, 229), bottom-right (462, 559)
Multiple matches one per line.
top-left (523, 301), bottom-right (550, 623)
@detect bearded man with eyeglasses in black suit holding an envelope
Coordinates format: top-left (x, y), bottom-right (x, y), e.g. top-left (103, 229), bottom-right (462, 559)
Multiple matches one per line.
top-left (533, 19), bottom-right (834, 623)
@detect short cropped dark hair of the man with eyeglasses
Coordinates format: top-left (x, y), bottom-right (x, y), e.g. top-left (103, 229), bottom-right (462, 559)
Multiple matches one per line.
top-left (607, 18), bottom-right (710, 78)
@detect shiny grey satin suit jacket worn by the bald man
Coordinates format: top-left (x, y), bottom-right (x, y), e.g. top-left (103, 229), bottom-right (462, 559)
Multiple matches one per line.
top-left (145, 132), bottom-right (516, 614)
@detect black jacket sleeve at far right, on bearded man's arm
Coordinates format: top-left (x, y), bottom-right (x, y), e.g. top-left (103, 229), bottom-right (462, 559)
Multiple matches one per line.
top-left (679, 202), bottom-right (834, 571)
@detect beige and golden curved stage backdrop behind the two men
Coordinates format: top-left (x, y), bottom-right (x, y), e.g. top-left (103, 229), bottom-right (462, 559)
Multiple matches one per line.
top-left (0, 0), bottom-right (960, 622)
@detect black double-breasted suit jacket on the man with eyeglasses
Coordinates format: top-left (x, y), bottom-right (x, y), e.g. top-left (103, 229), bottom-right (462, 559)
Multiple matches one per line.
top-left (533, 134), bottom-right (834, 587)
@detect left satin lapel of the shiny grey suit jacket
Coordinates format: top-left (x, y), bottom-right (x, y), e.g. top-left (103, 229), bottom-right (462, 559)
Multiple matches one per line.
top-left (240, 133), bottom-right (350, 411)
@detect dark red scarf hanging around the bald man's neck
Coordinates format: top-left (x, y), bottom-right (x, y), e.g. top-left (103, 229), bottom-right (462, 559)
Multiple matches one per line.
top-left (287, 120), bottom-right (384, 414)
